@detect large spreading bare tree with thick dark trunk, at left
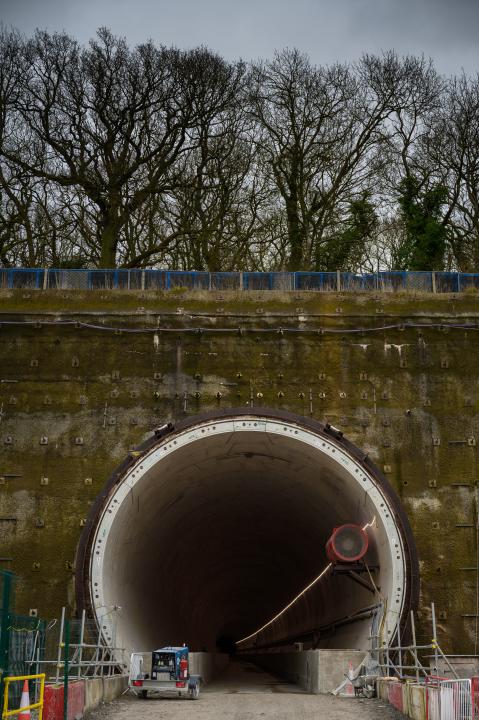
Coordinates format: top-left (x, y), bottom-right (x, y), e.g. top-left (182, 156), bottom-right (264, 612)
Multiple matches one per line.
top-left (4, 29), bottom-right (251, 267)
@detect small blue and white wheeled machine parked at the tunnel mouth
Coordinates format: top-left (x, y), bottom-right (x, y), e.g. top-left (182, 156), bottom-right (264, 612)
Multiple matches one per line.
top-left (128, 645), bottom-right (201, 700)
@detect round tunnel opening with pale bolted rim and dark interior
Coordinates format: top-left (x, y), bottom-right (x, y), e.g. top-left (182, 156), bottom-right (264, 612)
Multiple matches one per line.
top-left (76, 408), bottom-right (419, 651)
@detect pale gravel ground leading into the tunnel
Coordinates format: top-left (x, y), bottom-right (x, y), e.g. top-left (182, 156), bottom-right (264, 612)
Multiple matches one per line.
top-left (85, 663), bottom-right (404, 720)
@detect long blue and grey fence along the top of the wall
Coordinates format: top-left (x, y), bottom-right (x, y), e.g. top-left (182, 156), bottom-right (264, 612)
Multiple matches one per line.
top-left (0, 268), bottom-right (479, 293)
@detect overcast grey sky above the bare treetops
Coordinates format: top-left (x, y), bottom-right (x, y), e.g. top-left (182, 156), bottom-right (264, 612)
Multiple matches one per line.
top-left (0, 0), bottom-right (479, 74)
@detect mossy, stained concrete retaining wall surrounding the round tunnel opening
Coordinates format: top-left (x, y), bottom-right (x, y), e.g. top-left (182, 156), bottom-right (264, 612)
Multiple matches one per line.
top-left (0, 291), bottom-right (479, 652)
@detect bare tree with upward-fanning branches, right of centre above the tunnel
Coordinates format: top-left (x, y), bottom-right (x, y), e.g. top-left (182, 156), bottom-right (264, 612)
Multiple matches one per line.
top-left (251, 50), bottom-right (412, 269)
